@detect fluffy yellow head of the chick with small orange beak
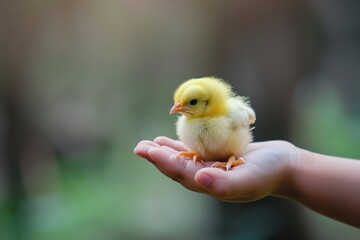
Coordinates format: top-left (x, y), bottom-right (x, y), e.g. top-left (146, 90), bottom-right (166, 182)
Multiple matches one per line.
top-left (170, 77), bottom-right (234, 119)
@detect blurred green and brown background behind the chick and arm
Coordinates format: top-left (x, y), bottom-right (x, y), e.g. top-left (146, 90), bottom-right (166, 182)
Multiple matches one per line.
top-left (0, 0), bottom-right (360, 240)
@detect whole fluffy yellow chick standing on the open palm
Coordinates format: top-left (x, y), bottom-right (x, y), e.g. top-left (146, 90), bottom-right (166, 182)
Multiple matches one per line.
top-left (170, 77), bottom-right (256, 170)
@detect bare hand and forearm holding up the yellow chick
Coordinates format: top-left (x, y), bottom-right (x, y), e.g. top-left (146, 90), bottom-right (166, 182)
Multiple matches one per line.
top-left (134, 137), bottom-right (360, 227)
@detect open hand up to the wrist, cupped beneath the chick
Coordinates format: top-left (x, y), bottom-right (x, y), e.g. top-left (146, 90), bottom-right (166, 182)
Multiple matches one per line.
top-left (134, 137), bottom-right (299, 202)
